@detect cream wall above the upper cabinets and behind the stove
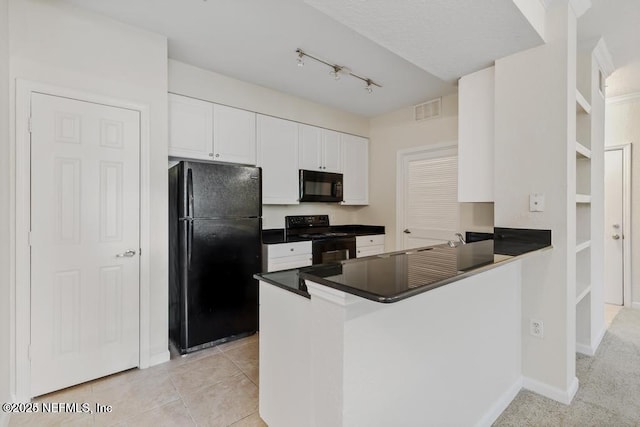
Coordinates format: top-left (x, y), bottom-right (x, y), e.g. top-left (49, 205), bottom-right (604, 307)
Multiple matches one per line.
top-left (169, 60), bottom-right (370, 228)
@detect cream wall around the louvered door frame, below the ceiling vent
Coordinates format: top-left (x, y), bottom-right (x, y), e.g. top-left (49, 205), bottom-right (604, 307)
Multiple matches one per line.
top-left (358, 95), bottom-right (493, 251)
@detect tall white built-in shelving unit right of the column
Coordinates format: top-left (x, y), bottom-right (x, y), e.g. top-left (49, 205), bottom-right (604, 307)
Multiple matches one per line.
top-left (569, 44), bottom-right (606, 355)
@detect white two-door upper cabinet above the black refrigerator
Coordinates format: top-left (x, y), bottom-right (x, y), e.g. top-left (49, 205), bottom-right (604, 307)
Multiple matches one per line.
top-left (169, 94), bottom-right (256, 165)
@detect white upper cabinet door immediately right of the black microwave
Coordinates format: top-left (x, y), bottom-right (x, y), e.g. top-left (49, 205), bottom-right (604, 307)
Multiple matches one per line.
top-left (342, 134), bottom-right (369, 205)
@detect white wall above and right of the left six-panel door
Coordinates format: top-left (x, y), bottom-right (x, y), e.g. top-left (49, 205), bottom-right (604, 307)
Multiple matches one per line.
top-left (8, 0), bottom-right (168, 372)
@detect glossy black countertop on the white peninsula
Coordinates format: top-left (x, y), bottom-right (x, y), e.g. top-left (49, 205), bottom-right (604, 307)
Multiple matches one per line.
top-left (254, 228), bottom-right (551, 303)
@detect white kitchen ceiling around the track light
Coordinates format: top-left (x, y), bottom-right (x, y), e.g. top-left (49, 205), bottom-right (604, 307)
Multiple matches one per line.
top-left (58, 0), bottom-right (640, 117)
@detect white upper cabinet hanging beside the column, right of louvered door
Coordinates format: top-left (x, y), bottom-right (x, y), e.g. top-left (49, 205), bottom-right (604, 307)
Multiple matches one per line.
top-left (458, 67), bottom-right (495, 202)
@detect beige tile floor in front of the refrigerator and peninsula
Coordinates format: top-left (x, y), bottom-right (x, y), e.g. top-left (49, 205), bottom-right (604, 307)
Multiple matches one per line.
top-left (9, 335), bottom-right (266, 427)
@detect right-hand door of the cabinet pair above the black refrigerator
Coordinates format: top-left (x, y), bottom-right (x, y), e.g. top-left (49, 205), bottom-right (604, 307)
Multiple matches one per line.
top-left (213, 104), bottom-right (256, 165)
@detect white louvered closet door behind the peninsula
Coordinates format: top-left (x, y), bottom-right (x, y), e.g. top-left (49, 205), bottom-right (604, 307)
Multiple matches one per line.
top-left (398, 148), bottom-right (459, 249)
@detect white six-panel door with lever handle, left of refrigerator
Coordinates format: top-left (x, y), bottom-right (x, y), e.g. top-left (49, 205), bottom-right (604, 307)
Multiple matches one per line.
top-left (30, 93), bottom-right (140, 396)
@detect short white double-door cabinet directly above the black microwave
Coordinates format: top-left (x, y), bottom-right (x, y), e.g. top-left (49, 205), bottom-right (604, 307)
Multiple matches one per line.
top-left (299, 124), bottom-right (342, 173)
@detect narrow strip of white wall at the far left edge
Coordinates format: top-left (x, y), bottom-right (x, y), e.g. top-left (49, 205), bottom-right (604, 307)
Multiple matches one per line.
top-left (0, 0), bottom-right (11, 414)
